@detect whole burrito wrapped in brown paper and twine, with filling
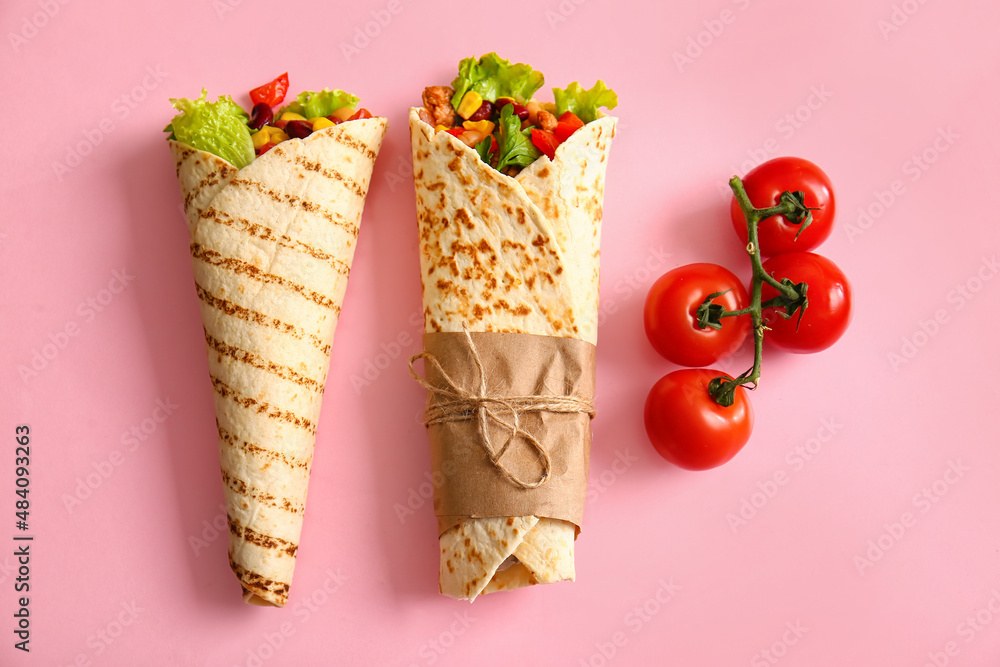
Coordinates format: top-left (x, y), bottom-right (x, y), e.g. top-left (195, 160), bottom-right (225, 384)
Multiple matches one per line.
top-left (409, 53), bottom-right (618, 601)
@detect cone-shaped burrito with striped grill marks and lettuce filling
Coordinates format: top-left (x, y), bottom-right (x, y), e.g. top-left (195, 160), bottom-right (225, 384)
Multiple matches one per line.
top-left (166, 75), bottom-right (387, 607)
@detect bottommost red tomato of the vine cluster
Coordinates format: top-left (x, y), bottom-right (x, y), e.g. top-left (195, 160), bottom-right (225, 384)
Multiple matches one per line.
top-left (645, 368), bottom-right (753, 470)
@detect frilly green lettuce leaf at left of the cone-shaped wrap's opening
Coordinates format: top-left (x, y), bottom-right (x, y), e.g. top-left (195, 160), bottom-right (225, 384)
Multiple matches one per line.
top-left (165, 88), bottom-right (254, 169)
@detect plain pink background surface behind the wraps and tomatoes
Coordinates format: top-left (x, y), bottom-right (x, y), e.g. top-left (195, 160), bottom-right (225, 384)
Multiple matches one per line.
top-left (0, 0), bottom-right (1000, 667)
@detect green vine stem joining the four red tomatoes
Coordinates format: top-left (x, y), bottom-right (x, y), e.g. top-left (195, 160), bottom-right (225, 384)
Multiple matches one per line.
top-left (703, 176), bottom-right (811, 406)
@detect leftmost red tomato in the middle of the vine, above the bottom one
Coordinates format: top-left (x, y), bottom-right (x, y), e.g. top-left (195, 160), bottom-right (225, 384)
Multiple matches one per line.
top-left (643, 264), bottom-right (750, 366)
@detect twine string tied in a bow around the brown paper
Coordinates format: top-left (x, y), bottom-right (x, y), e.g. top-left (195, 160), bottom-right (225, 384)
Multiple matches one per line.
top-left (410, 329), bottom-right (596, 489)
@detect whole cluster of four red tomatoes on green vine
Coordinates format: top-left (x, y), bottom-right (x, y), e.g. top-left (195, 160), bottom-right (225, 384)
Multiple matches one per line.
top-left (643, 158), bottom-right (851, 470)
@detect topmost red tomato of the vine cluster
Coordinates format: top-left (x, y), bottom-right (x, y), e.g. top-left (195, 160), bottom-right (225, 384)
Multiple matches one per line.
top-left (729, 157), bottom-right (837, 257)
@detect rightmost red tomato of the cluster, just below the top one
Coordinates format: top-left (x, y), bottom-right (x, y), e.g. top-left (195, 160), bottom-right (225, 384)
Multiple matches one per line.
top-left (761, 252), bottom-right (851, 352)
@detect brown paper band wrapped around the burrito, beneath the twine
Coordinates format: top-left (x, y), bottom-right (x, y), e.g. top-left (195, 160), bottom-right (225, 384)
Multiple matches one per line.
top-left (423, 332), bottom-right (596, 535)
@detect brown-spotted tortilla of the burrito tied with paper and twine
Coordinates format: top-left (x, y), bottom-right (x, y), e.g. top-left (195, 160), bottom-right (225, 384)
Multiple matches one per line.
top-left (410, 109), bottom-right (616, 600)
